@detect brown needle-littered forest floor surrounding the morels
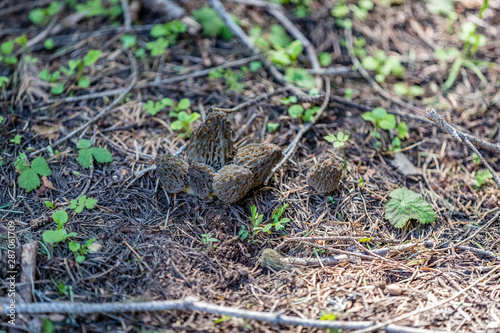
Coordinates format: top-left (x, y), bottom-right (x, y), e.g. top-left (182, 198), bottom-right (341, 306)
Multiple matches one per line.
top-left (0, 0), bottom-right (500, 332)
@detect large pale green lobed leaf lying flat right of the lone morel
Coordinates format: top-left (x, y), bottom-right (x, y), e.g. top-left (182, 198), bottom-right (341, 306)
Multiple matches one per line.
top-left (385, 188), bottom-right (436, 228)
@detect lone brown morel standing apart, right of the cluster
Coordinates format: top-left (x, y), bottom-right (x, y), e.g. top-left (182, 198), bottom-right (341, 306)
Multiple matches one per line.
top-left (307, 153), bottom-right (342, 194)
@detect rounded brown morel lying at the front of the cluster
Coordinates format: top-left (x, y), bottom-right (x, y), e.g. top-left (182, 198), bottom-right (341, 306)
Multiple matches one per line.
top-left (213, 164), bottom-right (253, 203)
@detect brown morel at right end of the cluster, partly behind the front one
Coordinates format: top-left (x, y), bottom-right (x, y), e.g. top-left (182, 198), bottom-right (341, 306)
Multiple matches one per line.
top-left (234, 143), bottom-right (283, 187)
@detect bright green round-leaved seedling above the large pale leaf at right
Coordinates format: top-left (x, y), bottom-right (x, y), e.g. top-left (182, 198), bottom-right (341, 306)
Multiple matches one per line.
top-left (361, 107), bottom-right (408, 152)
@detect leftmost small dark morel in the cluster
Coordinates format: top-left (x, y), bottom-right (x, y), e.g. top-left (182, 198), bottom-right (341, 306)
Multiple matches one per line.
top-left (156, 154), bottom-right (189, 193)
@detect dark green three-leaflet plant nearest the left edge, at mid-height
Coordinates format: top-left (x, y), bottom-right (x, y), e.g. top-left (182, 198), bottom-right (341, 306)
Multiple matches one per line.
top-left (15, 153), bottom-right (52, 192)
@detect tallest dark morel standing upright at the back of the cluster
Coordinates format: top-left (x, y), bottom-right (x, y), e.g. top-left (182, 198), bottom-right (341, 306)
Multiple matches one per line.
top-left (187, 111), bottom-right (233, 170)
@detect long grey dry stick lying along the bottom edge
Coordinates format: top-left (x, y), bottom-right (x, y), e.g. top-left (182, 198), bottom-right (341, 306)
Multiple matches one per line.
top-left (3, 297), bottom-right (442, 333)
